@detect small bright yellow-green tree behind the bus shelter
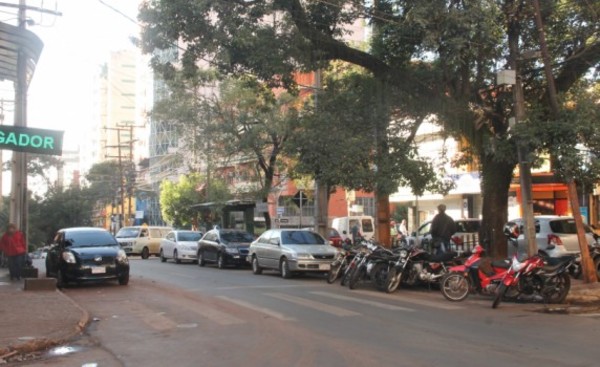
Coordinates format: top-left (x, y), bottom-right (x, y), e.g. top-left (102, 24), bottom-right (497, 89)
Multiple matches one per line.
top-left (160, 173), bottom-right (230, 228)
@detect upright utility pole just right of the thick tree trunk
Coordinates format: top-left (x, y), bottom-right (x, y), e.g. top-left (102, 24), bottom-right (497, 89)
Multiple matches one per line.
top-left (507, 1), bottom-right (538, 256)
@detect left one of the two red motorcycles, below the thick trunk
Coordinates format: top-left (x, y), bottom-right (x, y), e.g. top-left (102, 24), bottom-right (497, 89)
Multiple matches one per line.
top-left (440, 245), bottom-right (510, 302)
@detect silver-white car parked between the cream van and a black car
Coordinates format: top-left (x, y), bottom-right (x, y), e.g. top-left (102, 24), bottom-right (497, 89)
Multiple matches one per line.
top-left (159, 231), bottom-right (202, 264)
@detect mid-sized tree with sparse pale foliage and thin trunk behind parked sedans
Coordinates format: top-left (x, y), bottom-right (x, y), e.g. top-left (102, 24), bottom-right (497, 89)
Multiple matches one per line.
top-left (153, 70), bottom-right (298, 228)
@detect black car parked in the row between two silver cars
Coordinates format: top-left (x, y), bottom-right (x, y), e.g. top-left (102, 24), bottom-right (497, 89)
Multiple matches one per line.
top-left (198, 229), bottom-right (254, 269)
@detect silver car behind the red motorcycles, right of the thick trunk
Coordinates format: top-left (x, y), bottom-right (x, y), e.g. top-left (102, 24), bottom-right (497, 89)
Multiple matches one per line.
top-left (506, 215), bottom-right (596, 257)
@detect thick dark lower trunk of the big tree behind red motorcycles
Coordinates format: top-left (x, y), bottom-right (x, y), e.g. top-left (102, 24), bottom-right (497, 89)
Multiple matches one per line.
top-left (479, 155), bottom-right (515, 259)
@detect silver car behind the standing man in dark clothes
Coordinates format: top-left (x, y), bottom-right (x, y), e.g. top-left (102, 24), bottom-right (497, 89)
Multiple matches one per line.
top-left (406, 218), bottom-right (481, 250)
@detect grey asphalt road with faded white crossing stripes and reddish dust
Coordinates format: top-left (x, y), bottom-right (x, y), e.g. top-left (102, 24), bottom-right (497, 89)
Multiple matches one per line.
top-left (25, 258), bottom-right (600, 367)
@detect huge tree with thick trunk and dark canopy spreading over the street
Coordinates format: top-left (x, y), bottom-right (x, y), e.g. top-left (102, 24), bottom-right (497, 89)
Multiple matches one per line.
top-left (140, 0), bottom-right (600, 256)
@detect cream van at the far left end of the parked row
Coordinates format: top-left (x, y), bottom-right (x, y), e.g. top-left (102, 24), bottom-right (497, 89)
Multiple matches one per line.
top-left (116, 225), bottom-right (173, 259)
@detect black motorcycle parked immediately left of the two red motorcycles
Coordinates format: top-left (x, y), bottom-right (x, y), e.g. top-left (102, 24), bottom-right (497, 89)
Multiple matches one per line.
top-left (383, 246), bottom-right (457, 293)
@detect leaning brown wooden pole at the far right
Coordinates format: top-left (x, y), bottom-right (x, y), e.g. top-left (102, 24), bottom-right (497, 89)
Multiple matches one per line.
top-left (533, 0), bottom-right (598, 283)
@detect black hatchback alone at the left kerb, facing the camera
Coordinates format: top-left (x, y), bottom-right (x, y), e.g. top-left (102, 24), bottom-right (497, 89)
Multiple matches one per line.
top-left (46, 228), bottom-right (129, 287)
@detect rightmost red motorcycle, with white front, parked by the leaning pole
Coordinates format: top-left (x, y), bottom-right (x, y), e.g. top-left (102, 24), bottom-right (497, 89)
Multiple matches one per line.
top-left (492, 224), bottom-right (576, 308)
